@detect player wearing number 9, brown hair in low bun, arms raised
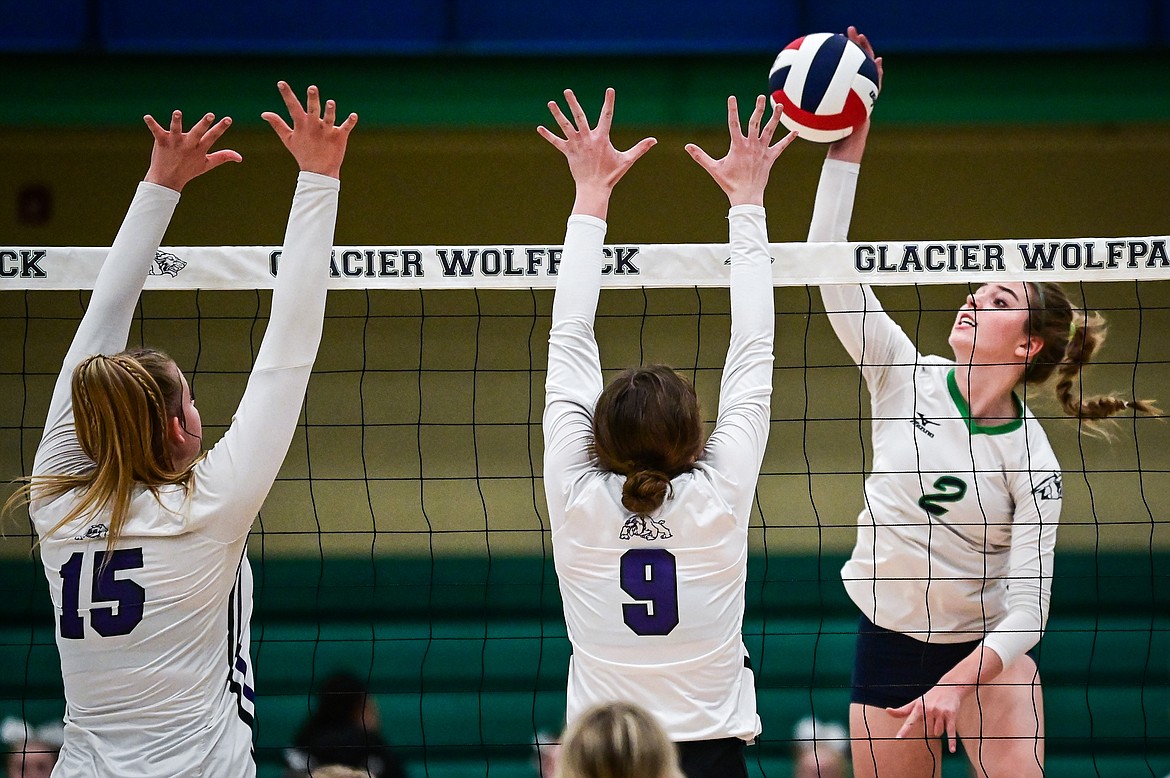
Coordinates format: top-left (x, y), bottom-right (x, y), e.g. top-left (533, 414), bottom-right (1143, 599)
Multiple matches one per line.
top-left (539, 90), bottom-right (793, 778)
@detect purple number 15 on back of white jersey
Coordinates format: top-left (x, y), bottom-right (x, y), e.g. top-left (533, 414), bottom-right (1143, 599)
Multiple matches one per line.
top-left (60, 549), bottom-right (146, 640)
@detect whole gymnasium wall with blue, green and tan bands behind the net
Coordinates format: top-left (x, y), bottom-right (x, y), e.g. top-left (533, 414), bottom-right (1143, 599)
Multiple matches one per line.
top-left (0, 0), bottom-right (1170, 555)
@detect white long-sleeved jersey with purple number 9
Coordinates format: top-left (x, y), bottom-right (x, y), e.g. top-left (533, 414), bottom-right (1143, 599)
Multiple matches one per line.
top-left (544, 206), bottom-right (775, 741)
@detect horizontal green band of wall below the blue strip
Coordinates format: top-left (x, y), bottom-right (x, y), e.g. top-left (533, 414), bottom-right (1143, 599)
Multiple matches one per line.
top-left (0, 51), bottom-right (1170, 128)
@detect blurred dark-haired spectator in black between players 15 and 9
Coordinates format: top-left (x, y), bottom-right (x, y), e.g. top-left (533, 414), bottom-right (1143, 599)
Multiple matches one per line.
top-left (284, 673), bottom-right (406, 778)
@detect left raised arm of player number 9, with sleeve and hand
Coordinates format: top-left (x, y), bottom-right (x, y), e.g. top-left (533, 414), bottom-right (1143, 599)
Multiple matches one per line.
top-left (537, 89), bottom-right (656, 521)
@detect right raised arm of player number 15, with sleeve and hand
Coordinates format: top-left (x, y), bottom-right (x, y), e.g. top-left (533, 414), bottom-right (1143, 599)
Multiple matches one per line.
top-left (193, 82), bottom-right (357, 541)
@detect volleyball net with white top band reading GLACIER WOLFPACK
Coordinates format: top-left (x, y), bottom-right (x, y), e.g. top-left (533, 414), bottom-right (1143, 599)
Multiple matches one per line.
top-left (0, 236), bottom-right (1170, 776)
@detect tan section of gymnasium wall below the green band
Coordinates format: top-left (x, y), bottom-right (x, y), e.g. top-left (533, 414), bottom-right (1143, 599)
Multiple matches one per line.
top-left (0, 126), bottom-right (1170, 557)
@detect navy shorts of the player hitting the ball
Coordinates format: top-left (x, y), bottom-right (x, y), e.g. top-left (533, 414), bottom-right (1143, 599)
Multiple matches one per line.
top-left (851, 615), bottom-right (980, 708)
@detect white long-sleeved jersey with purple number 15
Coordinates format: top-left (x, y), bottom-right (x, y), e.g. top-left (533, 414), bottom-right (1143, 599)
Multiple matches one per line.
top-left (30, 173), bottom-right (338, 778)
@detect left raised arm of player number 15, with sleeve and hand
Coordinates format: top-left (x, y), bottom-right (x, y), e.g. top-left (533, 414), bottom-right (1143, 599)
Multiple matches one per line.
top-left (33, 111), bottom-right (240, 475)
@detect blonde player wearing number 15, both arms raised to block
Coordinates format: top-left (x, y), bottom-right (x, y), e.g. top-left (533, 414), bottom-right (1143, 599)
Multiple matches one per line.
top-left (9, 82), bottom-right (357, 778)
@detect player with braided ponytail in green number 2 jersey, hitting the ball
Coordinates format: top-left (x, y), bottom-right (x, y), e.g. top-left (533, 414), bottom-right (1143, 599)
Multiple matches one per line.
top-left (808, 28), bottom-right (1156, 778)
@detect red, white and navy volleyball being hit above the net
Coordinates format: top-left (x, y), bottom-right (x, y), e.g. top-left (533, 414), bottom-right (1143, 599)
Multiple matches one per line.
top-left (768, 33), bottom-right (878, 143)
